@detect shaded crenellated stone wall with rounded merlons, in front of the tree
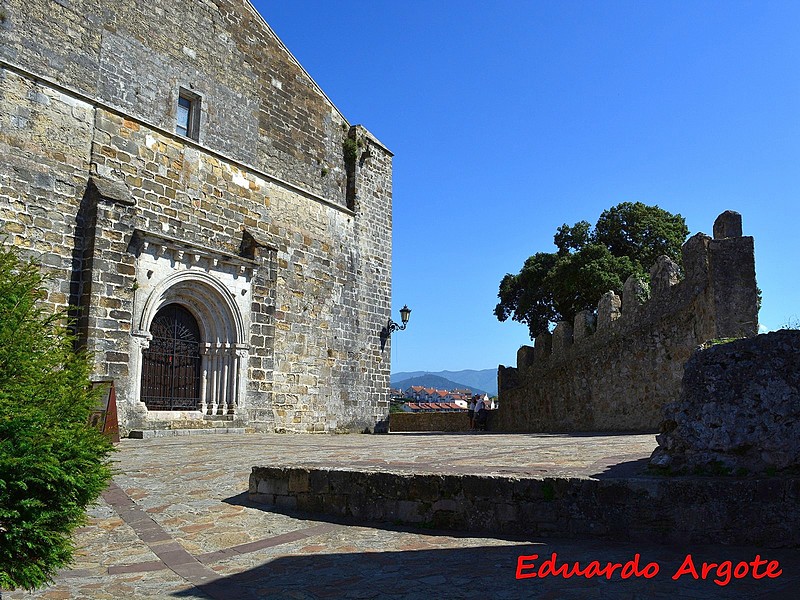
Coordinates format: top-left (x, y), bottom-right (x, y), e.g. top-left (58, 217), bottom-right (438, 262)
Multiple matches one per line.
top-left (493, 211), bottom-right (758, 432)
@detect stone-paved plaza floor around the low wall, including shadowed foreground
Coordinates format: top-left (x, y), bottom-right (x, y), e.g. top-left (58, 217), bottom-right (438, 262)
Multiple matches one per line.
top-left (9, 434), bottom-right (800, 600)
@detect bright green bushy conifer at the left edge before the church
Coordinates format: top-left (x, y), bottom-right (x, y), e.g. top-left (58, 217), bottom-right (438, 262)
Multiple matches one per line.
top-left (0, 248), bottom-right (112, 590)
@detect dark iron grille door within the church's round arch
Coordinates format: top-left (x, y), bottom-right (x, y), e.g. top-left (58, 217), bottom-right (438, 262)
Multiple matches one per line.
top-left (142, 304), bottom-right (201, 410)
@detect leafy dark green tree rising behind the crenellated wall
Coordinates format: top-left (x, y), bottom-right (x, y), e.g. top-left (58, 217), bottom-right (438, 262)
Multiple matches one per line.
top-left (494, 202), bottom-right (689, 338)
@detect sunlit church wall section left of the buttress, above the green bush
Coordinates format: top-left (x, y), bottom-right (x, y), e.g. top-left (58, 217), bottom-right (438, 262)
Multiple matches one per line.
top-left (0, 68), bottom-right (93, 316)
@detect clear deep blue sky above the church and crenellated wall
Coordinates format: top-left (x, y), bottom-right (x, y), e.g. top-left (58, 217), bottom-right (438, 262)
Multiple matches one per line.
top-left (255, 0), bottom-right (800, 372)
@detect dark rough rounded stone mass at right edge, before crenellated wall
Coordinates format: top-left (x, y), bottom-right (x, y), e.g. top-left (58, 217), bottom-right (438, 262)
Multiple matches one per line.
top-left (651, 331), bottom-right (800, 473)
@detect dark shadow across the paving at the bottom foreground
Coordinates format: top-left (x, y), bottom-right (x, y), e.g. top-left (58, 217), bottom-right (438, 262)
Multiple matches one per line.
top-left (173, 540), bottom-right (798, 600)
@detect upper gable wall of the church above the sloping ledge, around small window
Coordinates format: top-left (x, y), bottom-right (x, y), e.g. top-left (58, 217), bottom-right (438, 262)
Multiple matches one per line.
top-left (0, 0), bottom-right (349, 201)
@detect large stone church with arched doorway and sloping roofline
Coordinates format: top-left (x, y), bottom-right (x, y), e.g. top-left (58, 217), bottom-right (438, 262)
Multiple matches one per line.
top-left (0, 0), bottom-right (392, 433)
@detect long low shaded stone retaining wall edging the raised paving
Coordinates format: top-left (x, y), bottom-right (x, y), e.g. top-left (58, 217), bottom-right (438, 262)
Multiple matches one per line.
top-left (249, 467), bottom-right (800, 548)
